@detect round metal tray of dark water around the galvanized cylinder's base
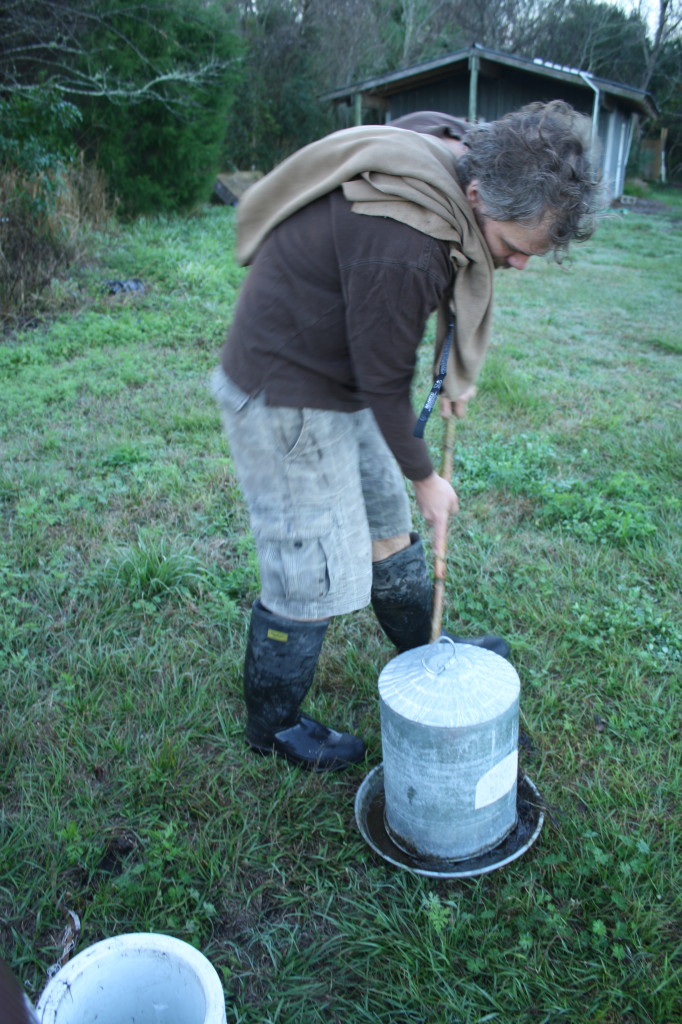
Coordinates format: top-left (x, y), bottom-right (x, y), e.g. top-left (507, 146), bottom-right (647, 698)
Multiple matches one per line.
top-left (355, 764), bottom-right (545, 879)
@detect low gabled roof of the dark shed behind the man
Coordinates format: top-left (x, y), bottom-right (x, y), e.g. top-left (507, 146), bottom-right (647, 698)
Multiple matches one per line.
top-left (324, 43), bottom-right (657, 118)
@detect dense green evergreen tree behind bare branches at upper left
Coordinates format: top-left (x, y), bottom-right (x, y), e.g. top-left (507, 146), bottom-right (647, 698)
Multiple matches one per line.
top-left (75, 0), bottom-right (238, 216)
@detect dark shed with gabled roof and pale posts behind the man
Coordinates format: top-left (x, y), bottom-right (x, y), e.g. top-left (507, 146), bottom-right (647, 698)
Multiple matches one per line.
top-left (324, 43), bottom-right (656, 199)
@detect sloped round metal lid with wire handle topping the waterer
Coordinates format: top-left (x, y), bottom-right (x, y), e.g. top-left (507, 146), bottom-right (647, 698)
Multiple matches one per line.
top-left (379, 637), bottom-right (520, 728)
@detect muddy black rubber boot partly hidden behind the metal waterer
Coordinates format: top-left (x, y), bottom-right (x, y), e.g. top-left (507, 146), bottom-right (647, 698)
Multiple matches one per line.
top-left (372, 534), bottom-right (510, 657)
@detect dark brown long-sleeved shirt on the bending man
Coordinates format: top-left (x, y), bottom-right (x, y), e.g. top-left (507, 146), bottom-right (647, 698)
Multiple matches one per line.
top-left (222, 189), bottom-right (454, 480)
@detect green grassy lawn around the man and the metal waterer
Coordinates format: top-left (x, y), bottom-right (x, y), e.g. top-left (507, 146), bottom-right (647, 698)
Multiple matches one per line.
top-left (0, 191), bottom-right (682, 1024)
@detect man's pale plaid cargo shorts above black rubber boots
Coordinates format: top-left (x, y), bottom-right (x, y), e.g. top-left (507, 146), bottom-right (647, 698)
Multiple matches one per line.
top-left (212, 369), bottom-right (412, 620)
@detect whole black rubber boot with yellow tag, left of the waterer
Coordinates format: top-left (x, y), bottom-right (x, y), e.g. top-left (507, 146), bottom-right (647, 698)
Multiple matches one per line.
top-left (244, 601), bottom-right (365, 771)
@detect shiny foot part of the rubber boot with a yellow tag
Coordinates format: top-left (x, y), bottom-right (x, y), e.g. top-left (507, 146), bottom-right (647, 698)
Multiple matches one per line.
top-left (247, 715), bottom-right (366, 771)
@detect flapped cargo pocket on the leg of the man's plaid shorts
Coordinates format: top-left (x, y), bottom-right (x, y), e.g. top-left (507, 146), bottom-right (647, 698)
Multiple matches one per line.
top-left (251, 506), bottom-right (334, 601)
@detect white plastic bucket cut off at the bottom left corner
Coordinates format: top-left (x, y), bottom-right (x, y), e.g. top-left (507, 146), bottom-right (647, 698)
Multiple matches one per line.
top-left (37, 933), bottom-right (226, 1024)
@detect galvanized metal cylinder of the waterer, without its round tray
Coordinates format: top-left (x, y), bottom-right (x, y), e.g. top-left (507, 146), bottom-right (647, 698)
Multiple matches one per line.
top-left (379, 637), bottom-right (520, 860)
